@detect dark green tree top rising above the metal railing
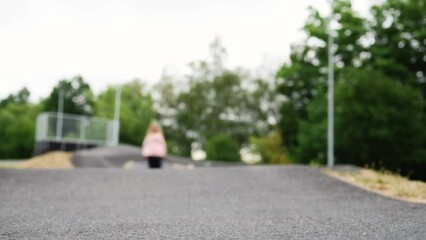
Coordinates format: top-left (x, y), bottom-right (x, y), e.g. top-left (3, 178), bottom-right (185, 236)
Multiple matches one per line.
top-left (43, 76), bottom-right (94, 116)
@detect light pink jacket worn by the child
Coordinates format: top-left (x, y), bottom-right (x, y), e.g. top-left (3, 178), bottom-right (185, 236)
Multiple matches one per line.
top-left (142, 132), bottom-right (167, 157)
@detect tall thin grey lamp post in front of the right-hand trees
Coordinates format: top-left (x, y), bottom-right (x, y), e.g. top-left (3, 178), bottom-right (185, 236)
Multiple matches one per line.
top-left (327, 0), bottom-right (334, 168)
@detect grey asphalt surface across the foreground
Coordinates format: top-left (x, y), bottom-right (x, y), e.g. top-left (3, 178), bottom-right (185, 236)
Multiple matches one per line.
top-left (0, 166), bottom-right (426, 239)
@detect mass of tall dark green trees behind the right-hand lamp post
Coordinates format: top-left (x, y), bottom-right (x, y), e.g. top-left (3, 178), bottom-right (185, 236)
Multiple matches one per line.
top-left (276, 0), bottom-right (426, 177)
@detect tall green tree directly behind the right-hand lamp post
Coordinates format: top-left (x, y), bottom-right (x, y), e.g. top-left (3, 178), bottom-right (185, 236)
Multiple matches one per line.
top-left (276, 0), bottom-right (367, 153)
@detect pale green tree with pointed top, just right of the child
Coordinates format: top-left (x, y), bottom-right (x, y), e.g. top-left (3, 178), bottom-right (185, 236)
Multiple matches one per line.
top-left (156, 40), bottom-right (276, 156)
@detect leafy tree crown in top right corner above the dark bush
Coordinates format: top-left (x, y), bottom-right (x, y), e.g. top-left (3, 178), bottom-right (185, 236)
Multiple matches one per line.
top-left (369, 0), bottom-right (426, 99)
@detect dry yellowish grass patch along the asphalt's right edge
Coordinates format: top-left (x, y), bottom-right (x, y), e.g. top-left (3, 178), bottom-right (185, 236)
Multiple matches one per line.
top-left (324, 169), bottom-right (426, 203)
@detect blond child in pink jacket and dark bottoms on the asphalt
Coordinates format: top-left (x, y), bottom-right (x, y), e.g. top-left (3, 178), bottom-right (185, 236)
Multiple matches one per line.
top-left (142, 123), bottom-right (167, 168)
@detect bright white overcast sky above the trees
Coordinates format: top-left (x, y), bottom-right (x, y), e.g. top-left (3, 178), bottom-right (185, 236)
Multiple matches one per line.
top-left (0, 0), bottom-right (369, 101)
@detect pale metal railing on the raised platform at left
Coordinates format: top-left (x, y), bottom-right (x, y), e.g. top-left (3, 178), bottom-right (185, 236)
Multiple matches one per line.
top-left (36, 112), bottom-right (119, 145)
